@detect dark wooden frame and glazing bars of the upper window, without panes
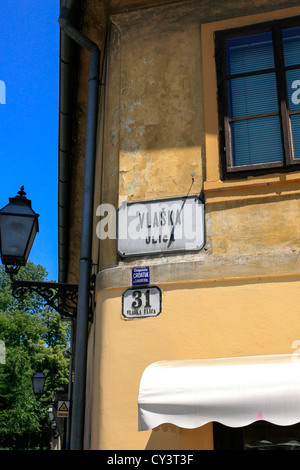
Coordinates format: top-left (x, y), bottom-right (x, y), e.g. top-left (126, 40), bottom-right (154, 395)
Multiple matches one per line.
top-left (215, 16), bottom-right (300, 179)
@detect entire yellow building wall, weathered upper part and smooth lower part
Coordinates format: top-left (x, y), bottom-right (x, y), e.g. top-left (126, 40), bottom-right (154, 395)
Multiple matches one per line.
top-left (86, 0), bottom-right (300, 449)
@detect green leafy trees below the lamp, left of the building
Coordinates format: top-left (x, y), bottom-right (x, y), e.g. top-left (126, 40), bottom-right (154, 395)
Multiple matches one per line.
top-left (0, 262), bottom-right (70, 449)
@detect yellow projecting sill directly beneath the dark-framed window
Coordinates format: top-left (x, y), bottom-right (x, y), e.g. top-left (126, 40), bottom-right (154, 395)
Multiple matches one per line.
top-left (203, 172), bottom-right (300, 203)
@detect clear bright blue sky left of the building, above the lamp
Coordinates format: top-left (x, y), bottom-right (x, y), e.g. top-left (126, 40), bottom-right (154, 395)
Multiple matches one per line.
top-left (0, 0), bottom-right (59, 280)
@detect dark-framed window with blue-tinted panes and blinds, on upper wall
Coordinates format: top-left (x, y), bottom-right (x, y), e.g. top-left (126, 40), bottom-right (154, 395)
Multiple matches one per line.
top-left (216, 18), bottom-right (300, 177)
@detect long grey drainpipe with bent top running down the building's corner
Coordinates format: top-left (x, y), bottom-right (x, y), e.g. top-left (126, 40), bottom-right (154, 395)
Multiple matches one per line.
top-left (58, 7), bottom-right (100, 450)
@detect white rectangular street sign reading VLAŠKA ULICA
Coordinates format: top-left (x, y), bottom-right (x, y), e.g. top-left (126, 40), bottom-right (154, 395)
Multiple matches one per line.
top-left (117, 196), bottom-right (205, 257)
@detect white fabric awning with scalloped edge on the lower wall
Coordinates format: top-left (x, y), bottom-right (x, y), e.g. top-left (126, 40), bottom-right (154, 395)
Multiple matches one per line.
top-left (138, 354), bottom-right (300, 431)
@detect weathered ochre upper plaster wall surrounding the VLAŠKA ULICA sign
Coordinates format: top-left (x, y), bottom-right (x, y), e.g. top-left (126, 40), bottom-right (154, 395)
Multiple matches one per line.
top-left (94, 1), bottom-right (300, 275)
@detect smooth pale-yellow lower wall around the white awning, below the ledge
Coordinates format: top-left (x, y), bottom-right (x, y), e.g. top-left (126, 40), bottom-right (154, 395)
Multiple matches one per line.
top-left (91, 276), bottom-right (299, 449)
